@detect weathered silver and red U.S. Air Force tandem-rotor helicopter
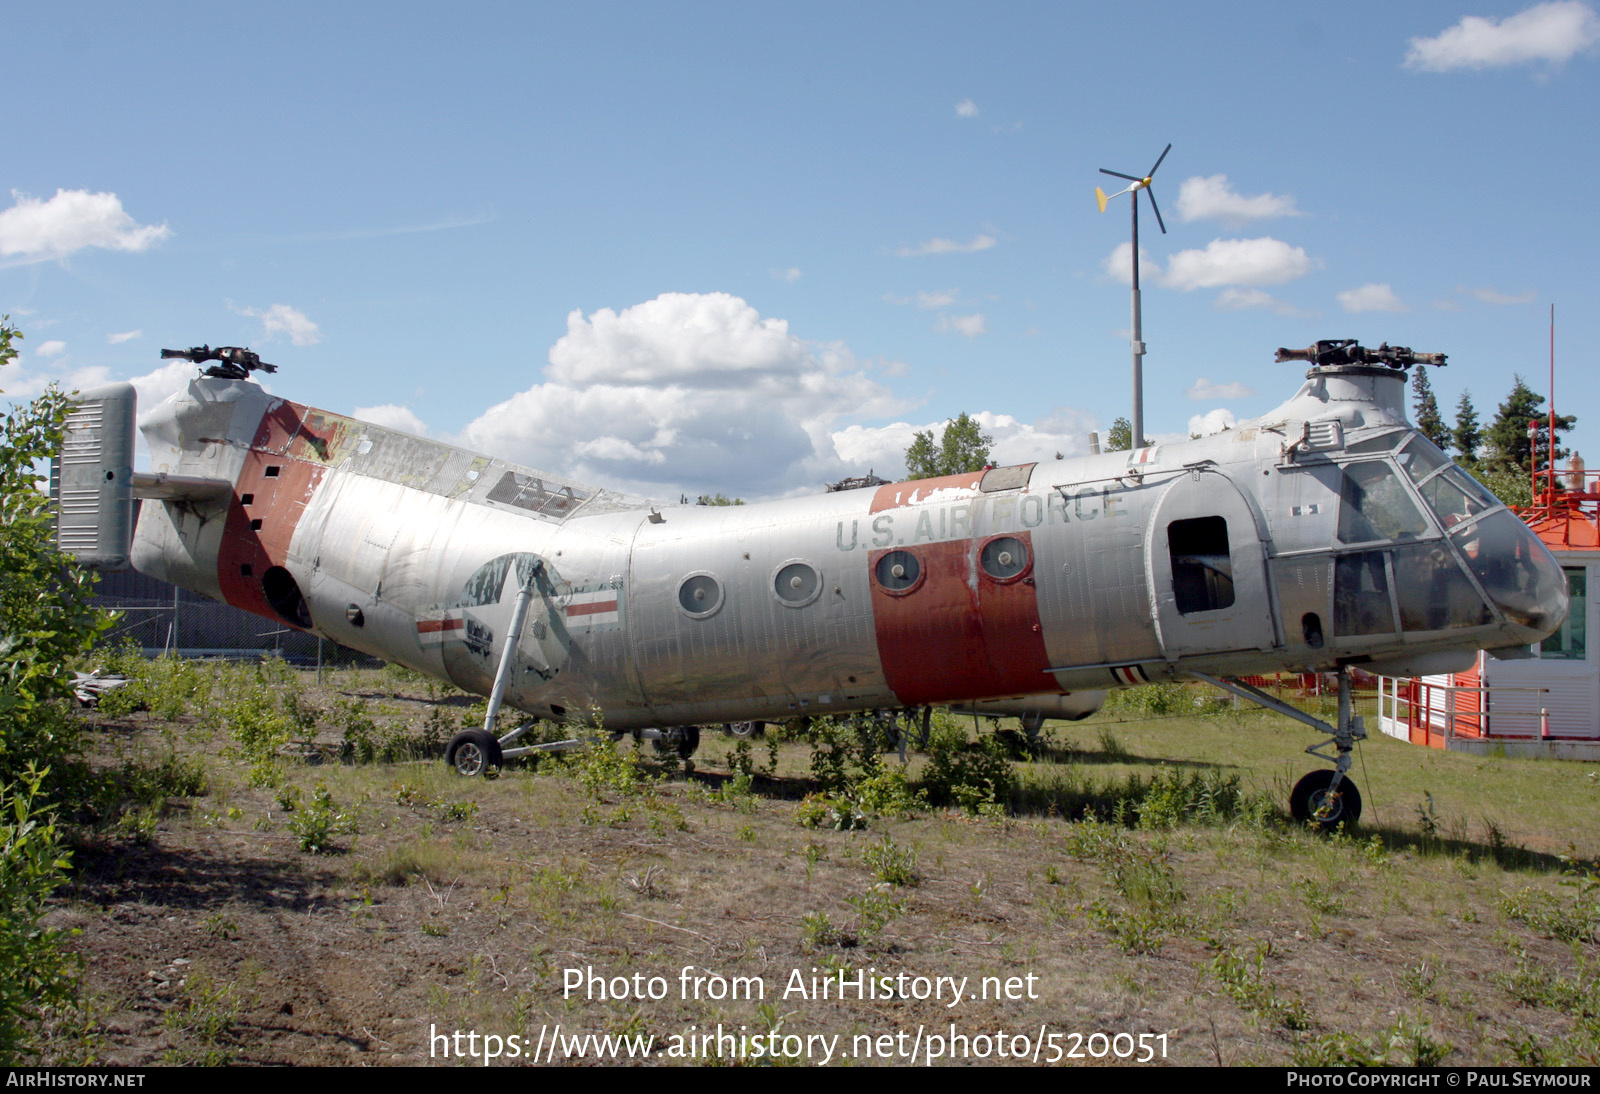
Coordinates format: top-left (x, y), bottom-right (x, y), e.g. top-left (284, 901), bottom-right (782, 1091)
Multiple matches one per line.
top-left (51, 339), bottom-right (1568, 828)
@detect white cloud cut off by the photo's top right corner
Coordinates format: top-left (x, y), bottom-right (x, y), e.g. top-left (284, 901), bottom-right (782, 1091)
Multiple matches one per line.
top-left (1405, 0), bottom-right (1600, 72)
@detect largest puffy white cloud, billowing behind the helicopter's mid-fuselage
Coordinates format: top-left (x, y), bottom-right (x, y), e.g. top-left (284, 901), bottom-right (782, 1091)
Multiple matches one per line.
top-left (461, 293), bottom-right (909, 499)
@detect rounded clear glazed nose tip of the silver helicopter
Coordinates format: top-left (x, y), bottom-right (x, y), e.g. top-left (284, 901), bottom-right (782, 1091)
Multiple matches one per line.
top-left (1453, 509), bottom-right (1568, 645)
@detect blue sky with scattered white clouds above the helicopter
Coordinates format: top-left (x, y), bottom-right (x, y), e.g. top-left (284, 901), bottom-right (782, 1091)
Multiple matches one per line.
top-left (0, 0), bottom-right (1600, 497)
